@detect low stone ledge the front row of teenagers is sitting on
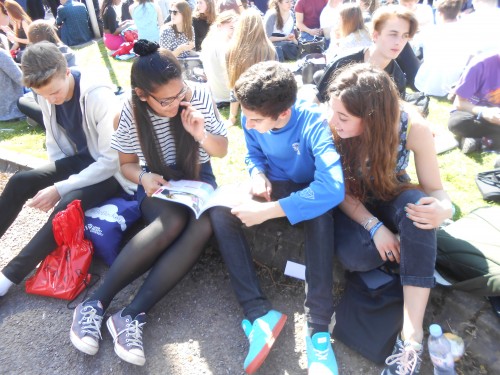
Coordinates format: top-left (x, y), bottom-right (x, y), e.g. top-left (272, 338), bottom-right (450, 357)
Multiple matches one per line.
top-left (0, 148), bottom-right (500, 374)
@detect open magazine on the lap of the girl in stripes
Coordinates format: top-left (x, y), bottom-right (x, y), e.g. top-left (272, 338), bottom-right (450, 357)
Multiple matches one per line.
top-left (153, 180), bottom-right (252, 219)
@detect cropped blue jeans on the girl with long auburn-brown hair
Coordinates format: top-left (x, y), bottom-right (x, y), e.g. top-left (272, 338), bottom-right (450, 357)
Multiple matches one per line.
top-left (334, 190), bottom-right (437, 288)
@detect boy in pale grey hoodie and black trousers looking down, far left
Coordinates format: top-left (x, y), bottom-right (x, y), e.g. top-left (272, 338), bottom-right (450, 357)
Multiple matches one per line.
top-left (0, 41), bottom-right (135, 302)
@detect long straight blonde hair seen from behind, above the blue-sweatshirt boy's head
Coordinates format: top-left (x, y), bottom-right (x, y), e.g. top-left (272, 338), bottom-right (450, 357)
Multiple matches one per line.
top-left (226, 9), bottom-right (276, 88)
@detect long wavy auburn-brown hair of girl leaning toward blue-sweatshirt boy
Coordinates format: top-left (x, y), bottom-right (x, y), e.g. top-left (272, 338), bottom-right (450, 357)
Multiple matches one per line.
top-left (328, 64), bottom-right (404, 202)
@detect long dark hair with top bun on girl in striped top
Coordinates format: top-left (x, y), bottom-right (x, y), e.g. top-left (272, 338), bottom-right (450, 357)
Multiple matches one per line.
top-left (130, 40), bottom-right (200, 180)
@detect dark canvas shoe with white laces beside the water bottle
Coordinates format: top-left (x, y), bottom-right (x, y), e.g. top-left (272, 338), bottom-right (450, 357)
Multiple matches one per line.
top-left (381, 335), bottom-right (424, 375)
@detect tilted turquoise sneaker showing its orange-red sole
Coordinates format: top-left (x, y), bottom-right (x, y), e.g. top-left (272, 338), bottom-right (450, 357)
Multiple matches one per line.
top-left (241, 310), bottom-right (287, 374)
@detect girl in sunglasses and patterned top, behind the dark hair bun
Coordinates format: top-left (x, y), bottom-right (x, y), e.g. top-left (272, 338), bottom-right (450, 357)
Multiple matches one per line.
top-left (160, 0), bottom-right (195, 58)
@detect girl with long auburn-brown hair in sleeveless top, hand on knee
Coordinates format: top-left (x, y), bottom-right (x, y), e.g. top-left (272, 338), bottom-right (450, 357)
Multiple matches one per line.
top-left (328, 64), bottom-right (453, 375)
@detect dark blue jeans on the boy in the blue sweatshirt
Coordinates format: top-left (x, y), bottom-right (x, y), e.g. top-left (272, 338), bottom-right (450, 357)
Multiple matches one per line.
top-left (210, 181), bottom-right (334, 325)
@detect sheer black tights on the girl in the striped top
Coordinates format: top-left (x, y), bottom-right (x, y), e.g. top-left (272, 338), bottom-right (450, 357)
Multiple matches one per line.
top-left (89, 197), bottom-right (212, 317)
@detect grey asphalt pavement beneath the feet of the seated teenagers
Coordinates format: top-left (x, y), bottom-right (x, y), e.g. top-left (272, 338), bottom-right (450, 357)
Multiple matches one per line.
top-left (0, 166), bottom-right (500, 375)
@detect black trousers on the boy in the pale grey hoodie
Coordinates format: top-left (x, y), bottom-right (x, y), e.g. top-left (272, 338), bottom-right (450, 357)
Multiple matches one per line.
top-left (0, 155), bottom-right (120, 284)
